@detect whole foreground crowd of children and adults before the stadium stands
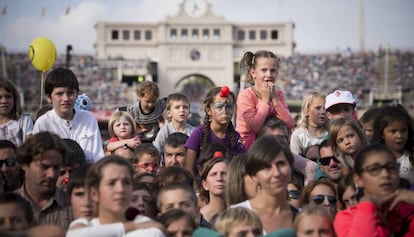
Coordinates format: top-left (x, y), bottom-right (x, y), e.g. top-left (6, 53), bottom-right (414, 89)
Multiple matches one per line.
top-left (0, 50), bottom-right (414, 237)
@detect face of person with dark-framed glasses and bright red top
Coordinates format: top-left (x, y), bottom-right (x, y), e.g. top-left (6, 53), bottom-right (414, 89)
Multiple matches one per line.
top-left (354, 151), bottom-right (399, 196)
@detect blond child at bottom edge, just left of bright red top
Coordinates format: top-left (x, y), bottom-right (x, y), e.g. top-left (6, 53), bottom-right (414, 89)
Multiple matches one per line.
top-left (293, 205), bottom-right (335, 237)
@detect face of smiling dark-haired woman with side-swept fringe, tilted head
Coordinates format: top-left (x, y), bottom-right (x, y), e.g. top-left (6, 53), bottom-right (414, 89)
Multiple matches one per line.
top-left (252, 152), bottom-right (292, 195)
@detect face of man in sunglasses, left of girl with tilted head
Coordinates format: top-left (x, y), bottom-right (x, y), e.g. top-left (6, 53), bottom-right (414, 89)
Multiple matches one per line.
top-left (319, 146), bottom-right (343, 183)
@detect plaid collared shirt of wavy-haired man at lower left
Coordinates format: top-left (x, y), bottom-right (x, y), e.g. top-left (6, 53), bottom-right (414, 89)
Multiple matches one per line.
top-left (15, 184), bottom-right (74, 230)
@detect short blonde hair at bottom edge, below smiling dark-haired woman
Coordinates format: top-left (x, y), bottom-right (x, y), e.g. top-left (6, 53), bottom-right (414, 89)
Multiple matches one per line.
top-left (214, 207), bottom-right (263, 236)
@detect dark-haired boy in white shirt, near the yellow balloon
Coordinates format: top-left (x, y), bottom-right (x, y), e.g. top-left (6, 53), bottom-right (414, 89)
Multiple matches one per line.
top-left (33, 68), bottom-right (104, 162)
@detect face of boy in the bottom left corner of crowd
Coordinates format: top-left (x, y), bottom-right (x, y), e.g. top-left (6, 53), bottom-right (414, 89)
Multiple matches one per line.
top-left (0, 203), bottom-right (30, 231)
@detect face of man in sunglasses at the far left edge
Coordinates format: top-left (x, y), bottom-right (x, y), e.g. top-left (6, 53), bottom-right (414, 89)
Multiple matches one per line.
top-left (0, 148), bottom-right (20, 189)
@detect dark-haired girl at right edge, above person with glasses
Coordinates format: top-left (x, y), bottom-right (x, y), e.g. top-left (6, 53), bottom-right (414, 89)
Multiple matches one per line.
top-left (373, 105), bottom-right (414, 185)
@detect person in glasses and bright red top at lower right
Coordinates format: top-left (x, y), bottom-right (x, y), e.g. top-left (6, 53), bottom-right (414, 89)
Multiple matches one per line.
top-left (334, 143), bottom-right (414, 237)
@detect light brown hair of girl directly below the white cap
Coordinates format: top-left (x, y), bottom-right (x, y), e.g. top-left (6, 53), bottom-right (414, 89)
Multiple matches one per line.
top-left (329, 118), bottom-right (368, 155)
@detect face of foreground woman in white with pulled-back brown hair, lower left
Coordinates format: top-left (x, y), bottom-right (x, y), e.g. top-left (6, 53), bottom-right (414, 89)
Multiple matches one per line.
top-left (91, 164), bottom-right (132, 219)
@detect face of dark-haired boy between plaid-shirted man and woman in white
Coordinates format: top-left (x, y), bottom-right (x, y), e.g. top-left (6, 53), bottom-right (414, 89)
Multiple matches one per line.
top-left (70, 187), bottom-right (98, 219)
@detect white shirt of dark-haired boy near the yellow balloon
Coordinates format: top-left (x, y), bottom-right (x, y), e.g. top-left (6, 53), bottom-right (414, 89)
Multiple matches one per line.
top-left (33, 109), bottom-right (104, 162)
